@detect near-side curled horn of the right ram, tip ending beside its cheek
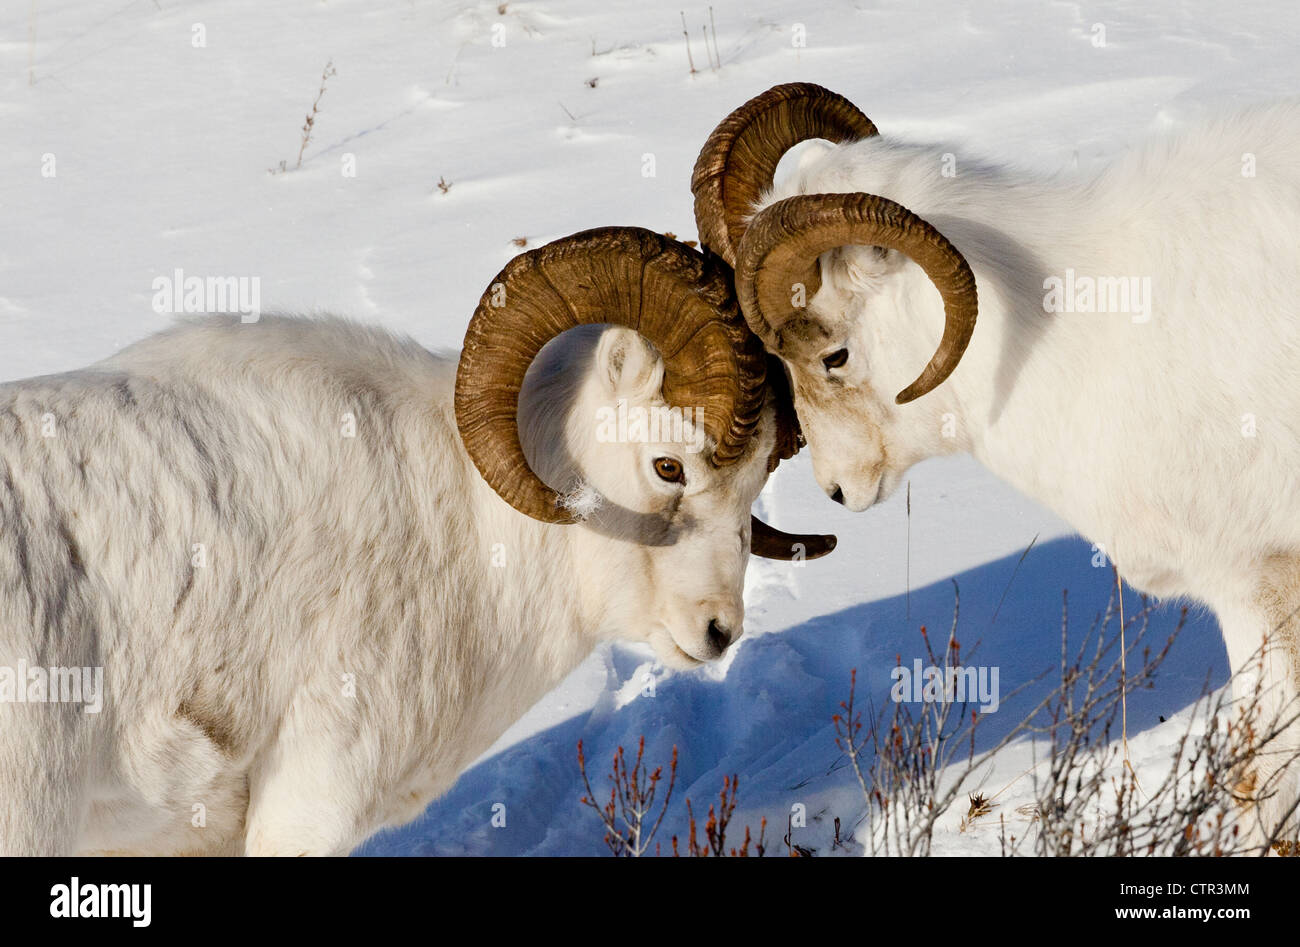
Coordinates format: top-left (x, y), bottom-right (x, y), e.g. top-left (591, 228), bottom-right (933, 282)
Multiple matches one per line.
top-left (736, 194), bottom-right (978, 405)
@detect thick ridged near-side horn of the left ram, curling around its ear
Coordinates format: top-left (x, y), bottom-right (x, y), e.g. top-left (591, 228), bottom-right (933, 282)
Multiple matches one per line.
top-left (455, 228), bottom-right (764, 523)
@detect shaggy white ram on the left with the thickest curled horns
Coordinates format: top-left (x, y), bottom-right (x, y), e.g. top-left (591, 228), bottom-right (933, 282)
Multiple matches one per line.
top-left (0, 228), bottom-right (833, 855)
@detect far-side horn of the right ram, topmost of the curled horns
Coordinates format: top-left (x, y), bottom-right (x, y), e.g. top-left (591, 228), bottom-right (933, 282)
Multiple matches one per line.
top-left (690, 82), bottom-right (878, 267)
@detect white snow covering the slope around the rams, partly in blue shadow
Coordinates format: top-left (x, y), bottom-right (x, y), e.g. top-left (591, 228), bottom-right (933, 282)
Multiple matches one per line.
top-left (0, 0), bottom-right (1300, 855)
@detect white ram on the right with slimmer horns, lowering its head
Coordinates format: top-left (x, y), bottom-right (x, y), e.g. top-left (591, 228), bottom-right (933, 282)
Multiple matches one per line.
top-left (692, 83), bottom-right (1300, 848)
